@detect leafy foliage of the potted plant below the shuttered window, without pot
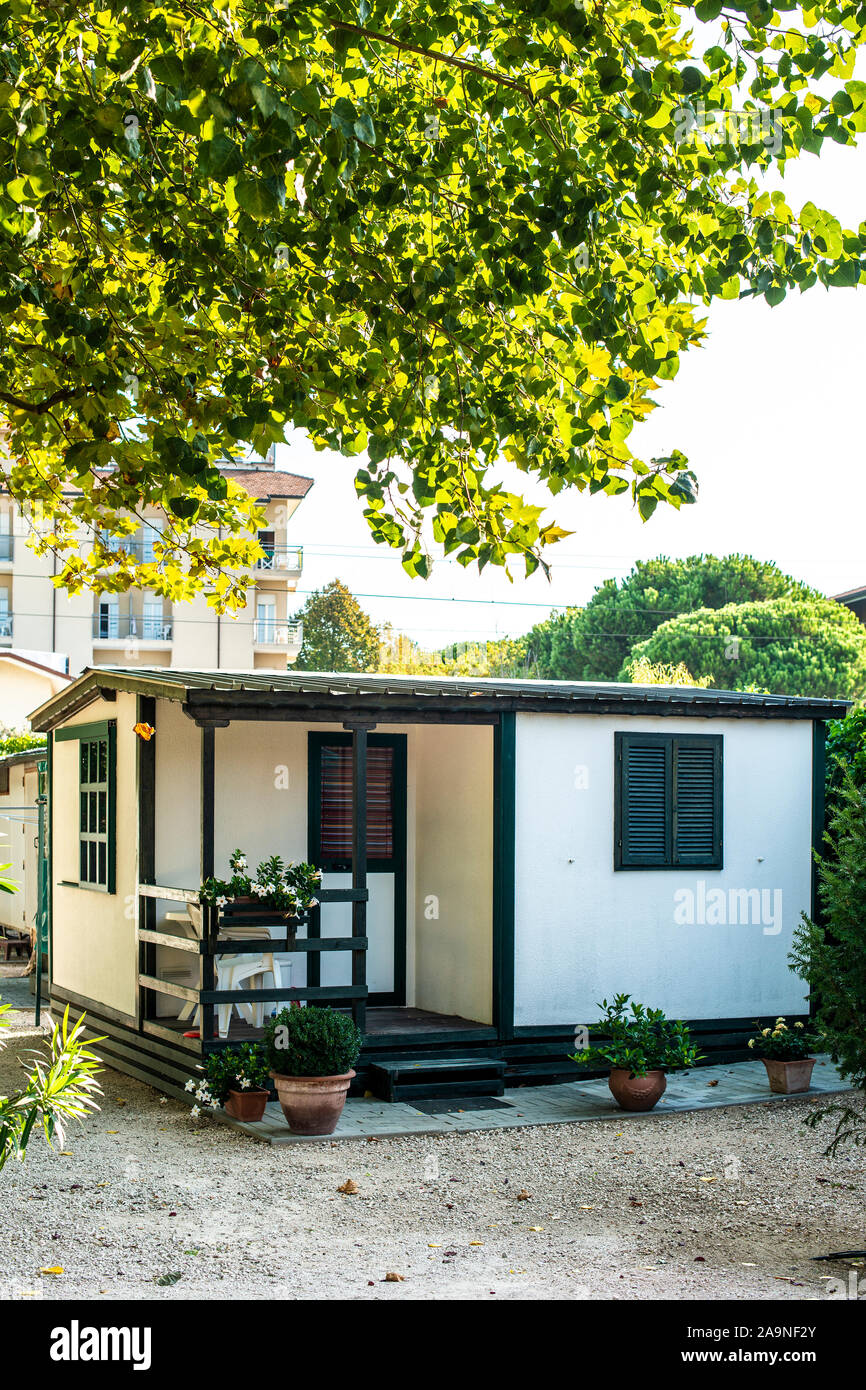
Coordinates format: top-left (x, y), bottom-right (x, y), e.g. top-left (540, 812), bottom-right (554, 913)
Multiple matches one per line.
top-left (570, 994), bottom-right (701, 1076)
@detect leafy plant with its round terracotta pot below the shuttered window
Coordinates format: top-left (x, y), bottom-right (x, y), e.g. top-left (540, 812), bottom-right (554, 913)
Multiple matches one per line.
top-left (571, 994), bottom-right (699, 1111)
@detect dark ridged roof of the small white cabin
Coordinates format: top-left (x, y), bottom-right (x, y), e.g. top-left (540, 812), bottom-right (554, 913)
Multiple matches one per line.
top-left (31, 666), bottom-right (851, 731)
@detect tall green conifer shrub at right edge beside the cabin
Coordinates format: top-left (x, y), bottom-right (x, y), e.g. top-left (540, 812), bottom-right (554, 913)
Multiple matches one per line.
top-left (790, 776), bottom-right (866, 1154)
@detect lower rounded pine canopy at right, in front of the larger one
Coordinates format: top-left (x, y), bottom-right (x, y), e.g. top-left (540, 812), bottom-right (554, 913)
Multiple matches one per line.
top-left (632, 598), bottom-right (866, 699)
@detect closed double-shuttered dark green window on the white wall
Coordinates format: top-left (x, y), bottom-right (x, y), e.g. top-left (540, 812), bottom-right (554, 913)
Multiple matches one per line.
top-left (613, 734), bottom-right (723, 869)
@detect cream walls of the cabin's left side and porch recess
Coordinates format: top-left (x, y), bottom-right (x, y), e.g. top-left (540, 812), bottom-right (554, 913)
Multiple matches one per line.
top-left (54, 692), bottom-right (493, 1023)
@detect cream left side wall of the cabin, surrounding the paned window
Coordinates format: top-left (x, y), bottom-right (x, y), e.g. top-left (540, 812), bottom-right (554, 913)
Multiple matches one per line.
top-left (51, 691), bottom-right (138, 1015)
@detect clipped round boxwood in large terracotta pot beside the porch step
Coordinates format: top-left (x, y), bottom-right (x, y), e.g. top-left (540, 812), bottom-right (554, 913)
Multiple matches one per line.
top-left (264, 1005), bottom-right (364, 1134)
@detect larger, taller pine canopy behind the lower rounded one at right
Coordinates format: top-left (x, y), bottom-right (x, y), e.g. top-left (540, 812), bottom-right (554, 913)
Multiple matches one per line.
top-left (528, 555), bottom-right (813, 681)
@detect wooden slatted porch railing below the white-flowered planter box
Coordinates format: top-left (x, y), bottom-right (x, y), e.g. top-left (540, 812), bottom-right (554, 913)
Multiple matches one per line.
top-left (138, 883), bottom-right (370, 1052)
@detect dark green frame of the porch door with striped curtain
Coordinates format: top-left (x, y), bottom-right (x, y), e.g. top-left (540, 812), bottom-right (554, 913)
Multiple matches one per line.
top-left (307, 733), bottom-right (407, 1005)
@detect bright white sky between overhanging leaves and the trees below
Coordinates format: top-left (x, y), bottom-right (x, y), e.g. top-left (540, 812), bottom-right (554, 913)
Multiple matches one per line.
top-left (277, 131), bottom-right (866, 649)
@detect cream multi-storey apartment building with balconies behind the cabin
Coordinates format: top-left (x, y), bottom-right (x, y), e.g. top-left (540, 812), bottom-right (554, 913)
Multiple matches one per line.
top-left (0, 457), bottom-right (313, 676)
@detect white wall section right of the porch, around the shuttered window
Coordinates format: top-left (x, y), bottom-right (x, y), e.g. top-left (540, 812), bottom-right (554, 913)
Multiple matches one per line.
top-left (514, 713), bottom-right (812, 1027)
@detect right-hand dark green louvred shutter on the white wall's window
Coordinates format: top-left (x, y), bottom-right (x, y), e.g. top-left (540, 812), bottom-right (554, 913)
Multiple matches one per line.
top-left (673, 735), bottom-right (721, 869)
